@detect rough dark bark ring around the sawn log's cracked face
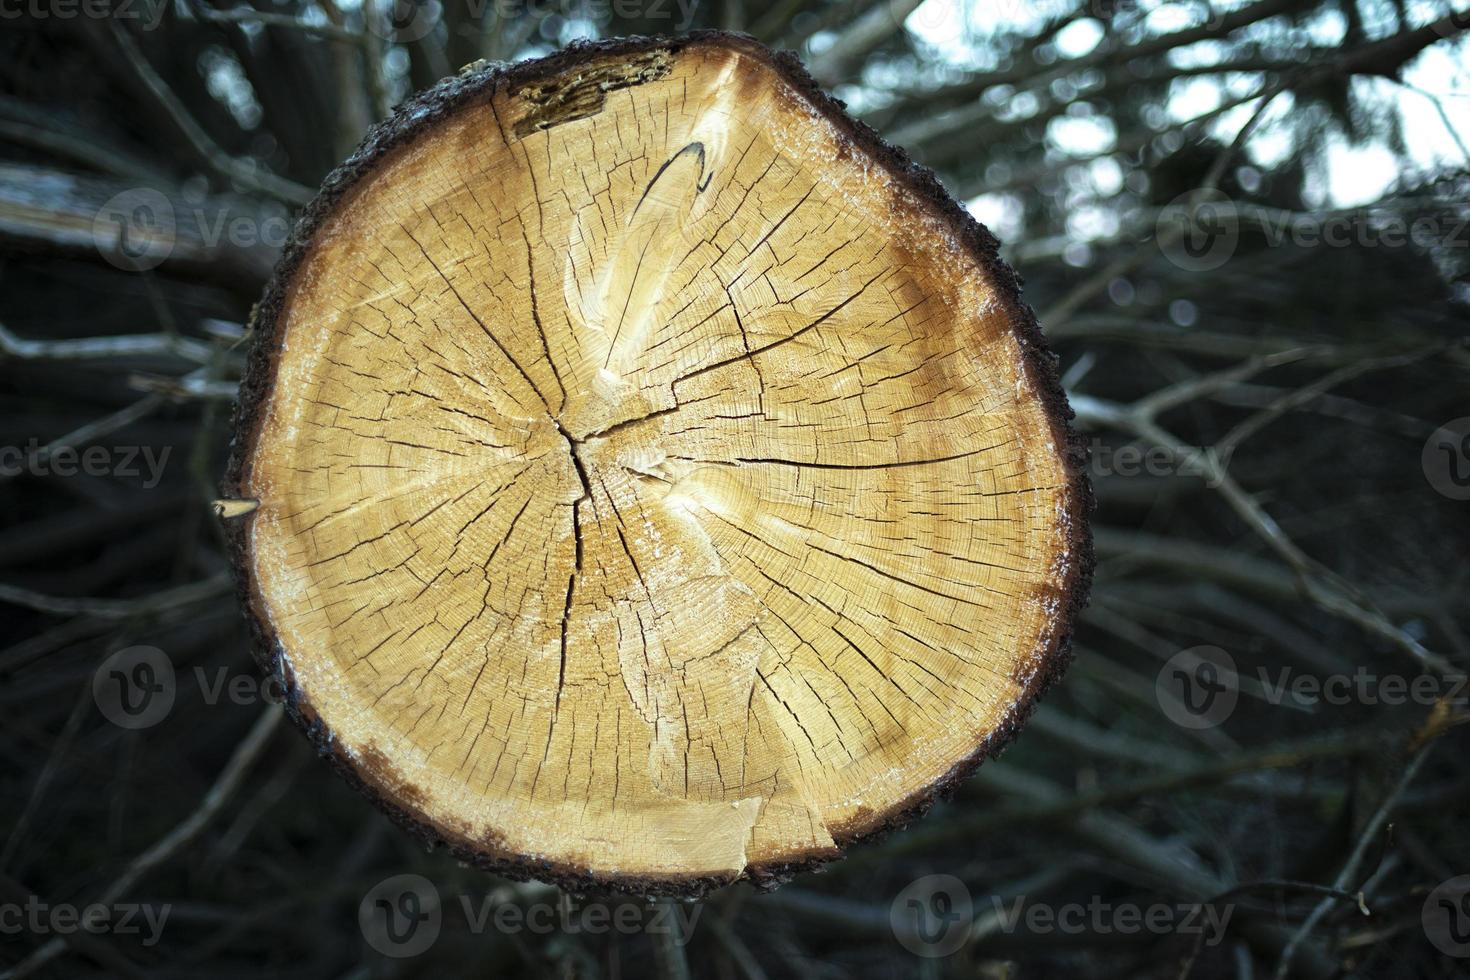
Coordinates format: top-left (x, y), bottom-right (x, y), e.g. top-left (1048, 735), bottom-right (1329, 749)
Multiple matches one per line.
top-left (221, 31), bottom-right (1094, 898)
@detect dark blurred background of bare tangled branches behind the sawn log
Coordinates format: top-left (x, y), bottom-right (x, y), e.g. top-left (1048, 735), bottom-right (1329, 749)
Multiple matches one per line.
top-left (0, 0), bottom-right (1470, 977)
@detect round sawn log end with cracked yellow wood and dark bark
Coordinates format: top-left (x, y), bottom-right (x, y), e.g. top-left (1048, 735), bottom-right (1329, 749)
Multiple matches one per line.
top-left (223, 34), bottom-right (1091, 893)
